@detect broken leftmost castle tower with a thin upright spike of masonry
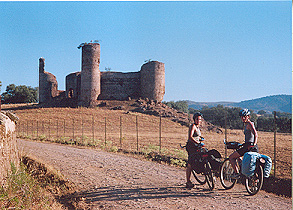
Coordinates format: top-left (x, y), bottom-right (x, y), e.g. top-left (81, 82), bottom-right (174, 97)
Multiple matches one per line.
top-left (39, 58), bottom-right (58, 103)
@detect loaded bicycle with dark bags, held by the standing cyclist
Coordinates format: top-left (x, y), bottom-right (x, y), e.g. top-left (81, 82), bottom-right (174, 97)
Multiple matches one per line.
top-left (180, 137), bottom-right (215, 190)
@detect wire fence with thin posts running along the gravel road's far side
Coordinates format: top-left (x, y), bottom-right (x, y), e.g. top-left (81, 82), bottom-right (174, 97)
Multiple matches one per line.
top-left (17, 115), bottom-right (292, 179)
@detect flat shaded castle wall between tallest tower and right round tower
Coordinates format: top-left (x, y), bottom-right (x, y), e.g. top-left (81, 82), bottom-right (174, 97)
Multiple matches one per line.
top-left (99, 72), bottom-right (140, 100)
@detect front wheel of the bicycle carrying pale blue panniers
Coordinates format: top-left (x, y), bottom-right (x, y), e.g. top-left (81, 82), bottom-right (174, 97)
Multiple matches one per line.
top-left (220, 159), bottom-right (237, 190)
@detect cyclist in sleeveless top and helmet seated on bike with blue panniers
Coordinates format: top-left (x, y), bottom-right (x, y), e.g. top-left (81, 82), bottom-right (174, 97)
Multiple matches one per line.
top-left (229, 109), bottom-right (258, 179)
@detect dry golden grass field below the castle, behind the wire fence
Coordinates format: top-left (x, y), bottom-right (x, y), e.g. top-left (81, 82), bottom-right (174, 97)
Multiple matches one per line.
top-left (2, 102), bottom-right (292, 179)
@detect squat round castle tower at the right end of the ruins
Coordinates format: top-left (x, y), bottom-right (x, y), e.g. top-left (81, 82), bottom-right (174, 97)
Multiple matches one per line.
top-left (140, 61), bottom-right (165, 102)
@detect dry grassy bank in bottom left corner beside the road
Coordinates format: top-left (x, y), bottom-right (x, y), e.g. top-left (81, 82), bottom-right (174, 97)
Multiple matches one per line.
top-left (0, 157), bottom-right (73, 210)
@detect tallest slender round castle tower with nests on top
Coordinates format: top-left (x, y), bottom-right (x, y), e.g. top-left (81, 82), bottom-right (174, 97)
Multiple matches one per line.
top-left (79, 43), bottom-right (101, 106)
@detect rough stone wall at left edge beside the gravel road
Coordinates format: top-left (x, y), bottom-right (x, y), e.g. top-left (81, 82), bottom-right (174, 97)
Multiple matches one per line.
top-left (0, 112), bottom-right (19, 185)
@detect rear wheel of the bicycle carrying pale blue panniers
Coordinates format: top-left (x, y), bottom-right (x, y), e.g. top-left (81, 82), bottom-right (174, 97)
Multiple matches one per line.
top-left (245, 165), bottom-right (263, 195)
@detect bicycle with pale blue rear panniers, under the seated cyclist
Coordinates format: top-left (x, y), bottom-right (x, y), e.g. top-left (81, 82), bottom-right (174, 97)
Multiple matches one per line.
top-left (220, 139), bottom-right (265, 195)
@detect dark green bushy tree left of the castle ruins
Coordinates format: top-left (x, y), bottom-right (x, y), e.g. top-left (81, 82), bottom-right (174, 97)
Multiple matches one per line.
top-left (1, 84), bottom-right (38, 104)
